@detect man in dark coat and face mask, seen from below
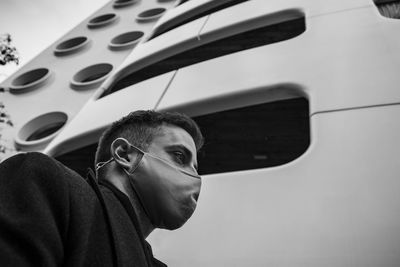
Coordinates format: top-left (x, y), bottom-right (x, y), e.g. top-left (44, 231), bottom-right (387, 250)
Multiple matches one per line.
top-left (0, 111), bottom-right (203, 266)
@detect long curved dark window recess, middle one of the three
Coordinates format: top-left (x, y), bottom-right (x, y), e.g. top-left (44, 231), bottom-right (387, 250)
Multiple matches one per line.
top-left (101, 11), bottom-right (306, 97)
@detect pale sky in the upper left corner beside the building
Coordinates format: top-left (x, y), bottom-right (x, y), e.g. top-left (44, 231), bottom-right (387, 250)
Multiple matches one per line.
top-left (0, 0), bottom-right (110, 82)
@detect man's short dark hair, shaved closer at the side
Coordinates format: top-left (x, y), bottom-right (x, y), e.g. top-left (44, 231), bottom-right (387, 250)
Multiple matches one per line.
top-left (95, 110), bottom-right (204, 164)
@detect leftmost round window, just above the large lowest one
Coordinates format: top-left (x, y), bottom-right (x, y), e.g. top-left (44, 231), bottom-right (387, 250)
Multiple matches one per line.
top-left (10, 68), bottom-right (50, 93)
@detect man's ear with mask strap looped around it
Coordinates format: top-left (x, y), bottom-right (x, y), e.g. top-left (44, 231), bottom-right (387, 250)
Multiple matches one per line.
top-left (111, 138), bottom-right (137, 170)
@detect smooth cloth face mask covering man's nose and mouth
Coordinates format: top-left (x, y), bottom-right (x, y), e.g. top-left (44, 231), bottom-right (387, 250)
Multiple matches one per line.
top-left (97, 142), bottom-right (201, 230)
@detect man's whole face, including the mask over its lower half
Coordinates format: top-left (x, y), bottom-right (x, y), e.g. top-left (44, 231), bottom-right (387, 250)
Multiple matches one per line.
top-left (131, 124), bottom-right (201, 230)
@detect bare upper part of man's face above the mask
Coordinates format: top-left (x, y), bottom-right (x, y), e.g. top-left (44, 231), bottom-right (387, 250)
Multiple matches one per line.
top-left (148, 124), bottom-right (197, 177)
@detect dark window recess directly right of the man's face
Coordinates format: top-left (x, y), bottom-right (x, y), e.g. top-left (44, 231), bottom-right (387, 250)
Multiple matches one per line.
top-left (193, 98), bottom-right (310, 175)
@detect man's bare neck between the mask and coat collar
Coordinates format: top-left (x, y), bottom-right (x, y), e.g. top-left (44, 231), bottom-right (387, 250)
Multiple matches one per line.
top-left (98, 162), bottom-right (154, 238)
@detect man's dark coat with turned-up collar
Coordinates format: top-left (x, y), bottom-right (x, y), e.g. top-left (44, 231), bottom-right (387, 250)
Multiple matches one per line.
top-left (0, 153), bottom-right (165, 267)
